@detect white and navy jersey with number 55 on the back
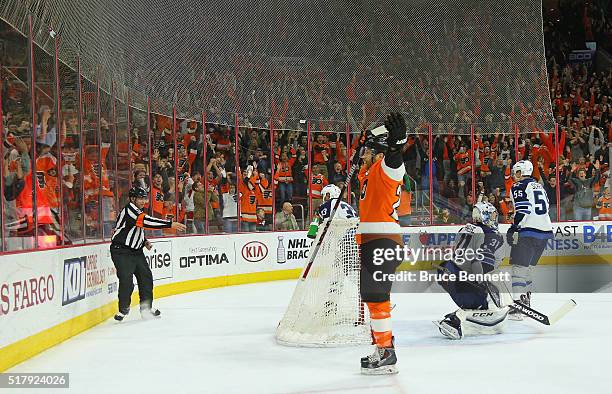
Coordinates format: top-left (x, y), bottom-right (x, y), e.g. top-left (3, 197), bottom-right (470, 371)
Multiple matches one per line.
top-left (511, 178), bottom-right (553, 239)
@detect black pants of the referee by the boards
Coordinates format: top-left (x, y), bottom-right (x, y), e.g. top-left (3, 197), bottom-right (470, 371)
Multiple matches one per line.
top-left (111, 245), bottom-right (153, 313)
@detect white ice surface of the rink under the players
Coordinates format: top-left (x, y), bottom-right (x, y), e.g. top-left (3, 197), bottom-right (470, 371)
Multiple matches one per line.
top-left (7, 281), bottom-right (612, 394)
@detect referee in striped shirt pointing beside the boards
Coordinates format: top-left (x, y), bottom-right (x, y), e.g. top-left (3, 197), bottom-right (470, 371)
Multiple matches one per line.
top-left (110, 186), bottom-right (185, 321)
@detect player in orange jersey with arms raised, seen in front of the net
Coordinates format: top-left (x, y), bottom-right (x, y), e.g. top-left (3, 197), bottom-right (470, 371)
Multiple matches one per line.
top-left (357, 113), bottom-right (406, 375)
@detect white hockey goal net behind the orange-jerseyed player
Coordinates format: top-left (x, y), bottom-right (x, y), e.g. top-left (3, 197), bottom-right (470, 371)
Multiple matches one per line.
top-left (276, 219), bottom-right (371, 347)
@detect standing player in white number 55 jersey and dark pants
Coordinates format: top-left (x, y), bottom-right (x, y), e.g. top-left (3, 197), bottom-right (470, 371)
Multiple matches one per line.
top-left (506, 160), bottom-right (553, 320)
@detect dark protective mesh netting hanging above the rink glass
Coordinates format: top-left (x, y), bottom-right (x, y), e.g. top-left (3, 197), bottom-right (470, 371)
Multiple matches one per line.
top-left (0, 0), bottom-right (553, 127)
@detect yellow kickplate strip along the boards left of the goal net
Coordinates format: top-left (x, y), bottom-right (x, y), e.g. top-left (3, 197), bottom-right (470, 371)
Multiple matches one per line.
top-left (0, 268), bottom-right (302, 372)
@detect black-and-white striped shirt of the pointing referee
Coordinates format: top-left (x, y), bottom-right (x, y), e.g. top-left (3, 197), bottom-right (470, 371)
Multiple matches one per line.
top-left (112, 202), bottom-right (172, 250)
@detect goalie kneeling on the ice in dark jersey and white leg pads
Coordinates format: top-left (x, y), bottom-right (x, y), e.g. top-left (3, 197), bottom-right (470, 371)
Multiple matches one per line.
top-left (434, 202), bottom-right (508, 339)
